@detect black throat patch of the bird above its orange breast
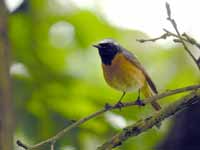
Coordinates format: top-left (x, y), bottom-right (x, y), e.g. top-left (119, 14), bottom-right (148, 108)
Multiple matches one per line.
top-left (99, 49), bottom-right (118, 65)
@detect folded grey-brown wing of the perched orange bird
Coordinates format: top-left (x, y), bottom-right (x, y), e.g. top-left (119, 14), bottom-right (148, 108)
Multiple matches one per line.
top-left (122, 49), bottom-right (158, 93)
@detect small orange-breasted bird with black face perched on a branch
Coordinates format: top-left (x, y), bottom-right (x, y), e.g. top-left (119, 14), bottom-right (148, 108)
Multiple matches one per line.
top-left (93, 38), bottom-right (161, 111)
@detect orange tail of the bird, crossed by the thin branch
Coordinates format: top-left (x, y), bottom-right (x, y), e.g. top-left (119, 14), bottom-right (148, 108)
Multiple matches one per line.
top-left (141, 84), bottom-right (161, 111)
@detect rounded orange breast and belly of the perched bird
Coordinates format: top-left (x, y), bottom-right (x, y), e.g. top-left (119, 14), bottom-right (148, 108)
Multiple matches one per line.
top-left (102, 53), bottom-right (145, 92)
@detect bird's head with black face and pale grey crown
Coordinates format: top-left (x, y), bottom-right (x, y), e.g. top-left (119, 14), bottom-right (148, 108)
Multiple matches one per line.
top-left (94, 40), bottom-right (120, 65)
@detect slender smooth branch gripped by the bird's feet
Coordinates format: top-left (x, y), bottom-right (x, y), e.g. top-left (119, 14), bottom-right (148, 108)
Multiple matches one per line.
top-left (17, 85), bottom-right (200, 150)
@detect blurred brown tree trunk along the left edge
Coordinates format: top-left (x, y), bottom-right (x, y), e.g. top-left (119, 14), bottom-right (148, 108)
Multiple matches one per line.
top-left (0, 0), bottom-right (13, 150)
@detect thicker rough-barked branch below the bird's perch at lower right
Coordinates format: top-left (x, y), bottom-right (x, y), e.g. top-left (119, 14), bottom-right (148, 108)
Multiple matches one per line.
top-left (97, 91), bottom-right (200, 150)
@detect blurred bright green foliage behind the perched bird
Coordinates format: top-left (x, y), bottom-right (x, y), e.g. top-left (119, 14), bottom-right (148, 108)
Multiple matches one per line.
top-left (4, 0), bottom-right (199, 150)
